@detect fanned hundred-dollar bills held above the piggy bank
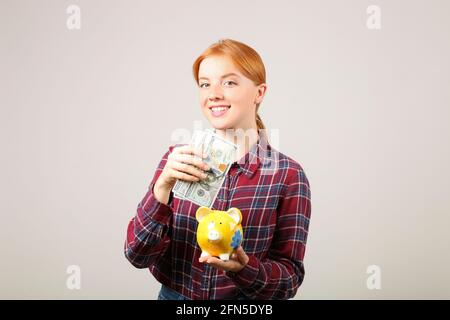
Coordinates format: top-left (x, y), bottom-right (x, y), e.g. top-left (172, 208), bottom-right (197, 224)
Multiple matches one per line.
top-left (172, 129), bottom-right (237, 208)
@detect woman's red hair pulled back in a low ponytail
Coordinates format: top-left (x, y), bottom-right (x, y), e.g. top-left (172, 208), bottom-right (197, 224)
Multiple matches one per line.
top-left (192, 39), bottom-right (266, 129)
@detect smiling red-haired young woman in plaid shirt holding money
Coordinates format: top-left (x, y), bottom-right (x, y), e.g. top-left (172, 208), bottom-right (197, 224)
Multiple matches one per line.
top-left (125, 39), bottom-right (311, 300)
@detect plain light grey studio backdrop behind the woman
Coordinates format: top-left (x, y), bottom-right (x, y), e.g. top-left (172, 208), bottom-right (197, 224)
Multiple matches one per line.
top-left (0, 0), bottom-right (450, 299)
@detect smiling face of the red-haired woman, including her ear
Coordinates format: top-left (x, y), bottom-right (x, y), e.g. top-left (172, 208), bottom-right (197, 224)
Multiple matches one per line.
top-left (198, 56), bottom-right (266, 130)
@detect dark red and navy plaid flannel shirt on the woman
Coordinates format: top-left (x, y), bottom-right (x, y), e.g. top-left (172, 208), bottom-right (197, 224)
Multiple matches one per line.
top-left (124, 136), bottom-right (311, 300)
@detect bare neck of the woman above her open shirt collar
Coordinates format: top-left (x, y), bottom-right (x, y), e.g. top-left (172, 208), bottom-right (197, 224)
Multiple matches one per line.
top-left (215, 126), bottom-right (259, 161)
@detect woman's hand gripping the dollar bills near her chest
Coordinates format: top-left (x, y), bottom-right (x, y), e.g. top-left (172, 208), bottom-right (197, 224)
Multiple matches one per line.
top-left (154, 145), bottom-right (209, 204)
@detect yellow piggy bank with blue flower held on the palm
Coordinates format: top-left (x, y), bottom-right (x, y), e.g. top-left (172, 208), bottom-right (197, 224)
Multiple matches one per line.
top-left (195, 207), bottom-right (243, 261)
